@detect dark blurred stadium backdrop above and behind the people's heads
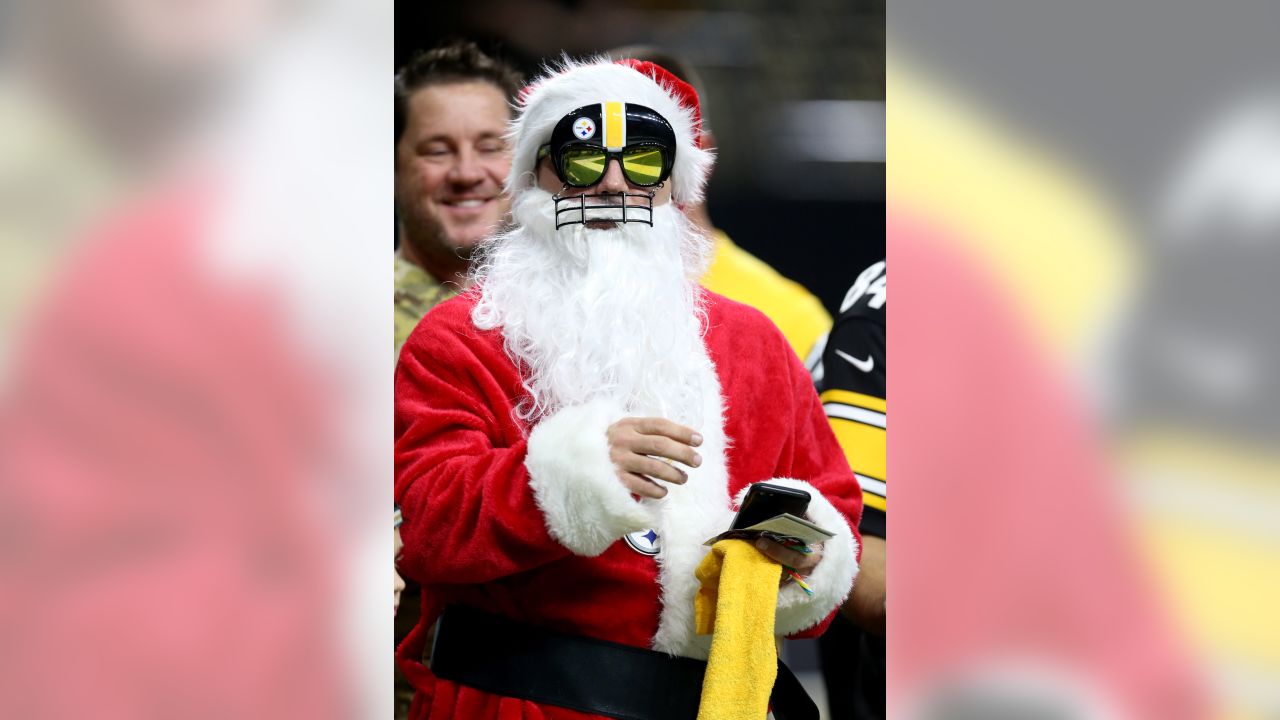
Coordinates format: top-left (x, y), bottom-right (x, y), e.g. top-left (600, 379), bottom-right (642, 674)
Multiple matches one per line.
top-left (396, 0), bottom-right (884, 314)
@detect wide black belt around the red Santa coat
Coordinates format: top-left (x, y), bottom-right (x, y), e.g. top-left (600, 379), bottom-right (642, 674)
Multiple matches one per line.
top-left (431, 606), bottom-right (818, 720)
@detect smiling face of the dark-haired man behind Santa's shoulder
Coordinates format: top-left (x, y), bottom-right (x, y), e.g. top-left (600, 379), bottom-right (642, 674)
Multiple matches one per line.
top-left (396, 81), bottom-right (511, 255)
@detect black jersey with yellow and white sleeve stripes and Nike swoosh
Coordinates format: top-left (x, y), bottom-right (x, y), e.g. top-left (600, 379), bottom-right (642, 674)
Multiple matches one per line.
top-left (813, 260), bottom-right (887, 537)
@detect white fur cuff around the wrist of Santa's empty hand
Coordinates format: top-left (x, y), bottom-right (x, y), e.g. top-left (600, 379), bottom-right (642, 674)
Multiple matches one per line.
top-left (525, 401), bottom-right (655, 557)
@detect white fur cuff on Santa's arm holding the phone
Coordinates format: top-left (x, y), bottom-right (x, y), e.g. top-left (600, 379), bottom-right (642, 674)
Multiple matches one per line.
top-left (735, 478), bottom-right (858, 635)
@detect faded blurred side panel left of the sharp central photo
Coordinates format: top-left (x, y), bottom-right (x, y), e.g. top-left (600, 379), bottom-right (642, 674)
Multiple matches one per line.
top-left (0, 0), bottom-right (392, 719)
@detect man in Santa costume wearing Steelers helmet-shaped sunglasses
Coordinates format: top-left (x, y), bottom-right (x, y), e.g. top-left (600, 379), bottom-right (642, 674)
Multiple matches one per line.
top-left (396, 60), bottom-right (861, 719)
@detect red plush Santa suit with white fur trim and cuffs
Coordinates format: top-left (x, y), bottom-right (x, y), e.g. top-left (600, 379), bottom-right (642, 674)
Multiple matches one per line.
top-left (396, 292), bottom-right (861, 720)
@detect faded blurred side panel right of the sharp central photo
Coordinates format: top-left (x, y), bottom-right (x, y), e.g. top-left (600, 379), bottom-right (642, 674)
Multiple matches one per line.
top-left (888, 0), bottom-right (1280, 717)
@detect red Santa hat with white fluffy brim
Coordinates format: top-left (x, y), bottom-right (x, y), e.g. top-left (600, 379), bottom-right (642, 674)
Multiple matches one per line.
top-left (507, 58), bottom-right (716, 205)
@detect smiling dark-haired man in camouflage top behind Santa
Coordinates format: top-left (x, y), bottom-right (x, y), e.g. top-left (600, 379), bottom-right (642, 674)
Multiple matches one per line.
top-left (396, 42), bottom-right (521, 355)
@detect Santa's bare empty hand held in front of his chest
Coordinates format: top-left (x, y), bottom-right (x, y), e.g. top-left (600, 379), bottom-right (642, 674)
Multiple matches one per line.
top-left (605, 418), bottom-right (703, 497)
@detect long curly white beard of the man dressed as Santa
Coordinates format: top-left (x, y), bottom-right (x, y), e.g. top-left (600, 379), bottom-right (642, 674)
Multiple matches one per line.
top-left (471, 187), bottom-right (710, 428)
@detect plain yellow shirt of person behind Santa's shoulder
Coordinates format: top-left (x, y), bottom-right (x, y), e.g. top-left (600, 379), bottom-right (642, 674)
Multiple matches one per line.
top-left (701, 231), bottom-right (831, 360)
